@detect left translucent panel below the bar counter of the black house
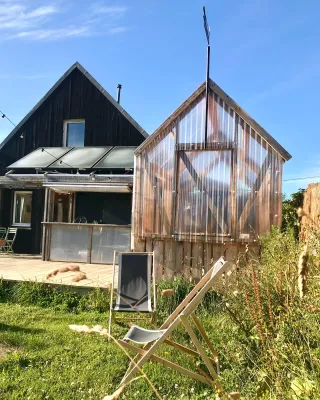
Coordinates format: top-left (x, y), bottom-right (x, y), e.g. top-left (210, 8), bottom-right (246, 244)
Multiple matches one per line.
top-left (50, 225), bottom-right (89, 262)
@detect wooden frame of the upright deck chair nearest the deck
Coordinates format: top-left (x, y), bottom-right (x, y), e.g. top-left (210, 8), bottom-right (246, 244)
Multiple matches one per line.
top-left (108, 251), bottom-right (157, 336)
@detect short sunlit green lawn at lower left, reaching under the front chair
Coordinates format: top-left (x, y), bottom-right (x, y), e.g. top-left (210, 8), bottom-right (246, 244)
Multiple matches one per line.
top-left (0, 304), bottom-right (225, 400)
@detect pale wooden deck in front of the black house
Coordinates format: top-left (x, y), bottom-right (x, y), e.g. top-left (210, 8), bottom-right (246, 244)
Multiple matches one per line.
top-left (0, 254), bottom-right (113, 289)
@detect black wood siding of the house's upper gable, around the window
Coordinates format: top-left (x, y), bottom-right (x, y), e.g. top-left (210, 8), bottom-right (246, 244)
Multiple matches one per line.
top-left (0, 69), bottom-right (144, 175)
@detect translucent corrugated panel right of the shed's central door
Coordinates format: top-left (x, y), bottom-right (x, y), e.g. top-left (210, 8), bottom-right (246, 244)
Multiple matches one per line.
top-left (236, 118), bottom-right (282, 240)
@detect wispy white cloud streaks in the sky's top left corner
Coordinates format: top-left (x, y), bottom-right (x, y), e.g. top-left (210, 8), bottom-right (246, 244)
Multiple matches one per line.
top-left (0, 0), bottom-right (128, 41)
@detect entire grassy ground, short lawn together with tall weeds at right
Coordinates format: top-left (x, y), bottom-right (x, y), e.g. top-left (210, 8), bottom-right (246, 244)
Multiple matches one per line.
top-left (0, 229), bottom-right (320, 400)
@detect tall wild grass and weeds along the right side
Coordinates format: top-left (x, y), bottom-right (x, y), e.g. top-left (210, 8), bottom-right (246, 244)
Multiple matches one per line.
top-left (224, 228), bottom-right (320, 399)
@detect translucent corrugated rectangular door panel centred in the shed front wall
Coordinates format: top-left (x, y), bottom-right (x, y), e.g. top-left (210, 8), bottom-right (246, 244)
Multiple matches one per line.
top-left (176, 150), bottom-right (231, 238)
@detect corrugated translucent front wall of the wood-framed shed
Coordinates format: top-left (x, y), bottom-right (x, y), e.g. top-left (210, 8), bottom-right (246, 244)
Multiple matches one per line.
top-left (134, 89), bottom-right (283, 243)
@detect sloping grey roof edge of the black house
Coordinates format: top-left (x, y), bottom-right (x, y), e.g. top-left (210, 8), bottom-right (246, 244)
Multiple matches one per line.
top-left (0, 62), bottom-right (149, 150)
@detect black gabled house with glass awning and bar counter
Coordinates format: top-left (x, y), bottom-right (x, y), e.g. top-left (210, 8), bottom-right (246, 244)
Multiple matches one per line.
top-left (0, 62), bottom-right (148, 262)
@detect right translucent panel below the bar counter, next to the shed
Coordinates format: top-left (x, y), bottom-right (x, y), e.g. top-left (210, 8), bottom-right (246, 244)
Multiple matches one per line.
top-left (91, 226), bottom-right (131, 264)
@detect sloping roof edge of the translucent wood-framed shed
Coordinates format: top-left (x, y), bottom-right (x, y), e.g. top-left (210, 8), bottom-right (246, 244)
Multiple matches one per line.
top-left (135, 79), bottom-right (292, 161)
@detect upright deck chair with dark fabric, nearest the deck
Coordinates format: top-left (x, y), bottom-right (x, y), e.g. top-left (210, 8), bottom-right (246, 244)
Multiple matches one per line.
top-left (108, 251), bottom-right (156, 335)
